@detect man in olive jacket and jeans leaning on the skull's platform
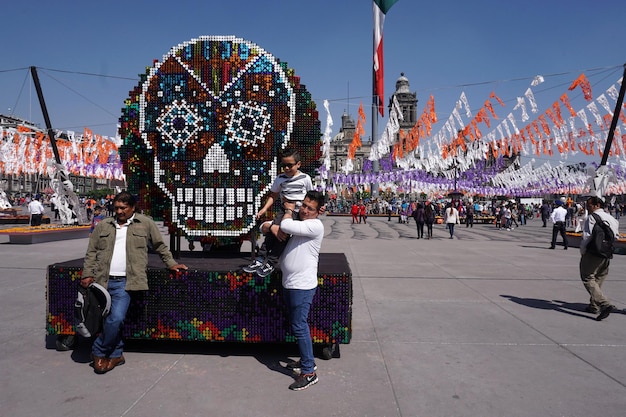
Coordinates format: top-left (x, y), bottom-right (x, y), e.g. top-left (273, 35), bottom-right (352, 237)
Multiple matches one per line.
top-left (80, 191), bottom-right (187, 374)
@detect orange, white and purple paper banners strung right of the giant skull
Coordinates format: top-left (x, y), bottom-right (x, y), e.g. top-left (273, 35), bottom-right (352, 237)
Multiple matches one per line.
top-left (320, 74), bottom-right (626, 196)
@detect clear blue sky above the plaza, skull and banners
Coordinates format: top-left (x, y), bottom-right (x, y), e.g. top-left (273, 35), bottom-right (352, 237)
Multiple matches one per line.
top-left (0, 0), bottom-right (626, 166)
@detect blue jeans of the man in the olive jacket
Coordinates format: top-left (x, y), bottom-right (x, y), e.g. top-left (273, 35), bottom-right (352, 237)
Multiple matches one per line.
top-left (92, 278), bottom-right (130, 358)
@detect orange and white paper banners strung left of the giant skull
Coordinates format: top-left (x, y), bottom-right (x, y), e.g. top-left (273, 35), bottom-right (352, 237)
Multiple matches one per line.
top-left (0, 126), bottom-right (124, 180)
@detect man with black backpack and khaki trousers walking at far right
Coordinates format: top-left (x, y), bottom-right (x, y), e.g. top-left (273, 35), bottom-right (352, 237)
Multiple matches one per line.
top-left (580, 197), bottom-right (619, 321)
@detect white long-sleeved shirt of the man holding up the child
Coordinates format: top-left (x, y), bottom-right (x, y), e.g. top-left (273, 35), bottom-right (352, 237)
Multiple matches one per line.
top-left (280, 218), bottom-right (324, 290)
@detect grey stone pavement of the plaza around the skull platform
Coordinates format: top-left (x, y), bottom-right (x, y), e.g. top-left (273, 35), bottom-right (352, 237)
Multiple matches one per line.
top-left (0, 216), bottom-right (626, 417)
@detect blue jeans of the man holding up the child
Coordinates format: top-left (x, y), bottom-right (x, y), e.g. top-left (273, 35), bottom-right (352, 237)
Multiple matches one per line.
top-left (283, 288), bottom-right (317, 374)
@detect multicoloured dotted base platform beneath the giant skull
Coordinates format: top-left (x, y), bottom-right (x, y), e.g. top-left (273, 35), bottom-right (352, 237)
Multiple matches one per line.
top-left (46, 252), bottom-right (352, 352)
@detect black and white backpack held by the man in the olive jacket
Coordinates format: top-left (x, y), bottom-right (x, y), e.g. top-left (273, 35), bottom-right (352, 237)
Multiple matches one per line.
top-left (74, 282), bottom-right (111, 338)
